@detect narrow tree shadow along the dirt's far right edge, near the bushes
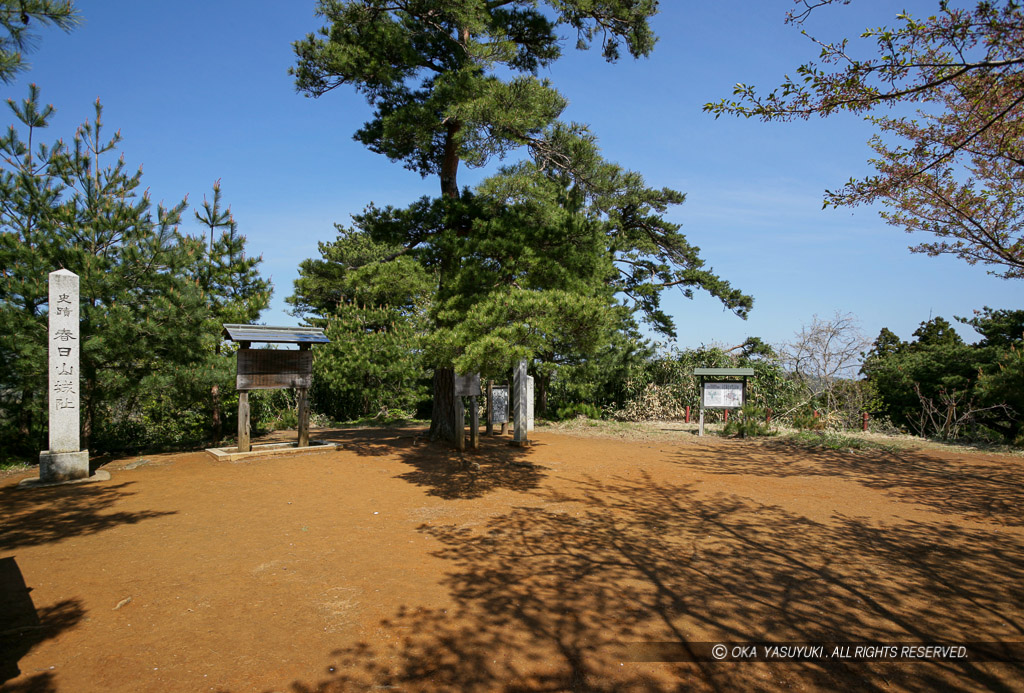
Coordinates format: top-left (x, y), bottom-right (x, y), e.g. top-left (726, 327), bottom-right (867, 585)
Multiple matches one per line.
top-left (676, 440), bottom-right (1024, 527)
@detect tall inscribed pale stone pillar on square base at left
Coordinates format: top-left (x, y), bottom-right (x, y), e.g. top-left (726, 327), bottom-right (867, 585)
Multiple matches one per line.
top-left (39, 269), bottom-right (89, 482)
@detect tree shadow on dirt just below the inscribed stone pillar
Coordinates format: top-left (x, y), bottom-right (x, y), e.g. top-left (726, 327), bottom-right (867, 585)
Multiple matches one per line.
top-left (0, 482), bottom-right (175, 551)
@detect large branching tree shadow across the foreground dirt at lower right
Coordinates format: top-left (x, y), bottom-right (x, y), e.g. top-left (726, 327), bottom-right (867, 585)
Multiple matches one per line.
top-left (276, 476), bottom-right (1024, 693)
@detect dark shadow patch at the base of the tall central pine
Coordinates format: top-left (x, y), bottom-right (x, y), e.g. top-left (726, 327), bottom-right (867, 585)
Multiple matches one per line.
top-left (317, 429), bottom-right (547, 501)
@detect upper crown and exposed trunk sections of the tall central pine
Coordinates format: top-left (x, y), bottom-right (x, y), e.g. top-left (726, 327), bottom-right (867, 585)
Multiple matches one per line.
top-left (293, 0), bottom-right (656, 440)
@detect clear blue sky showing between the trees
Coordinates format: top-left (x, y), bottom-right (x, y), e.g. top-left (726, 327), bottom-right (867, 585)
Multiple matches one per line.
top-left (9, 0), bottom-right (1024, 347)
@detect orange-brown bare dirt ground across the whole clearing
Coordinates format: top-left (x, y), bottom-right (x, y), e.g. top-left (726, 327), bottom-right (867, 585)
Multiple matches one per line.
top-left (0, 421), bottom-right (1024, 693)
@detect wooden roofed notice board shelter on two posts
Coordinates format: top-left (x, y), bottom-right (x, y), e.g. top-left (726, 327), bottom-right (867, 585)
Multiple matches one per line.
top-left (223, 324), bottom-right (331, 452)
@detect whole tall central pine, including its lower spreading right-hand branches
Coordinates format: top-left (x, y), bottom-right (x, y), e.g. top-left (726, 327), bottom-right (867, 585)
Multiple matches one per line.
top-left (293, 0), bottom-right (750, 440)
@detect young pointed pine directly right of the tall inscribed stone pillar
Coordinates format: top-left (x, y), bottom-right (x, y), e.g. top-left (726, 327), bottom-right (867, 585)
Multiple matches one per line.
top-left (48, 95), bottom-right (209, 445)
